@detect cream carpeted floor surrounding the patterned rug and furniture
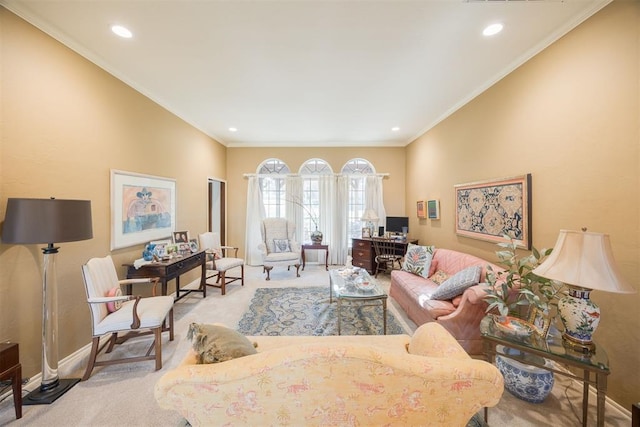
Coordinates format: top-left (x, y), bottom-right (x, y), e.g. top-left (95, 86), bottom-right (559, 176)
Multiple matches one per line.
top-left (0, 264), bottom-right (631, 427)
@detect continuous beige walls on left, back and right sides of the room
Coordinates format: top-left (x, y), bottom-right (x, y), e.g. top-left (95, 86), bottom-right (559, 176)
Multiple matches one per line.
top-left (0, 1), bottom-right (640, 408)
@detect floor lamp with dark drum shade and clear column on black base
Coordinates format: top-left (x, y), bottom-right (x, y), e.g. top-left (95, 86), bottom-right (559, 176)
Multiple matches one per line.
top-left (2, 198), bottom-right (93, 405)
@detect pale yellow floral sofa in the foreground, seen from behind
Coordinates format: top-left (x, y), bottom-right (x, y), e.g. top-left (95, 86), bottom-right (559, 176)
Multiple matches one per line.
top-left (155, 323), bottom-right (503, 426)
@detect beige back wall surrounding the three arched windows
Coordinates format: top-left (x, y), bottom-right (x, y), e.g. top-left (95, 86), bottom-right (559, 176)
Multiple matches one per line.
top-left (227, 147), bottom-right (406, 253)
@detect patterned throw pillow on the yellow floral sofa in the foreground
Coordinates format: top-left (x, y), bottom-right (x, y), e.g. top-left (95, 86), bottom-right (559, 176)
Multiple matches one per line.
top-left (187, 323), bottom-right (257, 364)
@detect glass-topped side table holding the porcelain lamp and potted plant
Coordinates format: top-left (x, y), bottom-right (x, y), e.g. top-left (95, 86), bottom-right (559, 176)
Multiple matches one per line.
top-left (480, 316), bottom-right (609, 427)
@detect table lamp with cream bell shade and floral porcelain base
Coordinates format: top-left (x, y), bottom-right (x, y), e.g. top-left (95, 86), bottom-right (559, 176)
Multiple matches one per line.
top-left (533, 232), bottom-right (636, 353)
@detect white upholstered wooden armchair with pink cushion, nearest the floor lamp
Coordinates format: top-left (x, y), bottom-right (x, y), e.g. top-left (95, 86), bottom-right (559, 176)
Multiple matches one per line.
top-left (82, 256), bottom-right (173, 381)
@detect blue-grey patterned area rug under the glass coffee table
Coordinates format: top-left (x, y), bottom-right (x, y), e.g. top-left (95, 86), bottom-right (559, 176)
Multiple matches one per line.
top-left (238, 286), bottom-right (410, 336)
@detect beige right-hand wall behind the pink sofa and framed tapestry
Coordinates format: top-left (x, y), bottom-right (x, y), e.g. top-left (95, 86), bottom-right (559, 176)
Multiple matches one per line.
top-left (406, 1), bottom-right (640, 409)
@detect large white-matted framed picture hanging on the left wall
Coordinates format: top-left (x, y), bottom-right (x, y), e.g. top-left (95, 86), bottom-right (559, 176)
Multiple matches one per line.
top-left (111, 169), bottom-right (176, 250)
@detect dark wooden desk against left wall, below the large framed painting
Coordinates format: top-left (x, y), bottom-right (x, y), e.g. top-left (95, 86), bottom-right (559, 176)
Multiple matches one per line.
top-left (125, 250), bottom-right (207, 301)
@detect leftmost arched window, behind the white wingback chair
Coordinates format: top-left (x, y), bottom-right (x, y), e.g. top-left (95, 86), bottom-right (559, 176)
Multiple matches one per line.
top-left (258, 159), bottom-right (290, 218)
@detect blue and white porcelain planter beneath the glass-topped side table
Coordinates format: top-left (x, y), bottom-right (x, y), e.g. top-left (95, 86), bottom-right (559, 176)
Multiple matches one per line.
top-left (496, 346), bottom-right (554, 403)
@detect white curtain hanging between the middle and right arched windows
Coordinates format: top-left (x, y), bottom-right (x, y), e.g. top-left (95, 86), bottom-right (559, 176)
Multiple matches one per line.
top-left (329, 175), bottom-right (349, 265)
